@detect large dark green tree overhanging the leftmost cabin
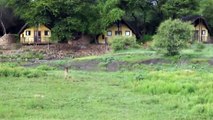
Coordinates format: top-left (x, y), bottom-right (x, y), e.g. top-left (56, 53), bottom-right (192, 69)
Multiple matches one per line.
top-left (9, 0), bottom-right (93, 41)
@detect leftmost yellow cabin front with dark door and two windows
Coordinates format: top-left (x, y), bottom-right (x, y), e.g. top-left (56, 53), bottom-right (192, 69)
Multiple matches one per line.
top-left (19, 25), bottom-right (51, 44)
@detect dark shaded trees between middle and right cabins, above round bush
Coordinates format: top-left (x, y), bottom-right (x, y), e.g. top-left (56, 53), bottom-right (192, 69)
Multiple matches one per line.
top-left (121, 0), bottom-right (199, 38)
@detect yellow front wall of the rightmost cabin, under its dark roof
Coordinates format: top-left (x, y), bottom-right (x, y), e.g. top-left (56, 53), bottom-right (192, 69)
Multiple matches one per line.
top-left (195, 23), bottom-right (209, 42)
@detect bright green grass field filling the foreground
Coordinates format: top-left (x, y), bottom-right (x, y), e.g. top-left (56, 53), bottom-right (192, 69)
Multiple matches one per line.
top-left (0, 45), bottom-right (213, 120)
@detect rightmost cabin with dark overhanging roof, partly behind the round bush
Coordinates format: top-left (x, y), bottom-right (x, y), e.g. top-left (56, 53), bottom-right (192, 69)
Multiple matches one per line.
top-left (182, 15), bottom-right (211, 42)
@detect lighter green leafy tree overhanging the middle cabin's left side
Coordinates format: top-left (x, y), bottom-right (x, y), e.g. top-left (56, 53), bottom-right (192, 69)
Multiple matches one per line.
top-left (88, 0), bottom-right (124, 42)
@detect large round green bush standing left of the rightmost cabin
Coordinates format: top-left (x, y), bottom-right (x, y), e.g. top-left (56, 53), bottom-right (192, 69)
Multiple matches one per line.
top-left (154, 19), bottom-right (193, 56)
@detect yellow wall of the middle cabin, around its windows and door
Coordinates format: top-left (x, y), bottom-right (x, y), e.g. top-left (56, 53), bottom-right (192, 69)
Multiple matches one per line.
top-left (98, 24), bottom-right (135, 44)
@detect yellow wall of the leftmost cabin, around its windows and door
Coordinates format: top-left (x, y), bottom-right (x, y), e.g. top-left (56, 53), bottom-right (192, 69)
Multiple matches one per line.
top-left (20, 25), bottom-right (51, 44)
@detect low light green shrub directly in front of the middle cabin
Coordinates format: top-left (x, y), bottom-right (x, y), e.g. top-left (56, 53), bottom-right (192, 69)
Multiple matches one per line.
top-left (110, 36), bottom-right (139, 51)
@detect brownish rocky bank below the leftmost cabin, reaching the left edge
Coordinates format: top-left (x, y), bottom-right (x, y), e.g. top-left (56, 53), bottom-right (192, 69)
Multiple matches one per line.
top-left (0, 44), bottom-right (107, 60)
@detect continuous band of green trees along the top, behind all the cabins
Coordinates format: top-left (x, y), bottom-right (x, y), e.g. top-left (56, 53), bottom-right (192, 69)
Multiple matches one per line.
top-left (0, 0), bottom-right (213, 41)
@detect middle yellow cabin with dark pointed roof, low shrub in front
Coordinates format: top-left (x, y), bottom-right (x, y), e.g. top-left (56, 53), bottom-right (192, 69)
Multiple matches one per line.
top-left (97, 20), bottom-right (135, 44)
